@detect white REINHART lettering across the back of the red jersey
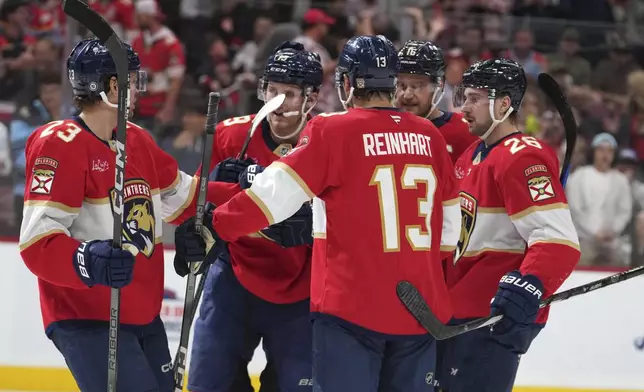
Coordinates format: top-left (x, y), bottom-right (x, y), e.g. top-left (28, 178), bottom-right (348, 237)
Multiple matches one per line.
top-left (362, 132), bottom-right (432, 157)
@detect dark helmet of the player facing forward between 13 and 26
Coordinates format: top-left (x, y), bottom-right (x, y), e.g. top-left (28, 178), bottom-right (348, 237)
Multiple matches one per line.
top-left (398, 40), bottom-right (445, 81)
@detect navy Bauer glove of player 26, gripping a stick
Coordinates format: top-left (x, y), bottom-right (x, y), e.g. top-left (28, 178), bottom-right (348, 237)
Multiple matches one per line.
top-left (490, 271), bottom-right (543, 353)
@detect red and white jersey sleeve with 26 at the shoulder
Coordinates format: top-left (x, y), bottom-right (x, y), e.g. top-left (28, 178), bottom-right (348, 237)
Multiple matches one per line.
top-left (495, 145), bottom-right (580, 295)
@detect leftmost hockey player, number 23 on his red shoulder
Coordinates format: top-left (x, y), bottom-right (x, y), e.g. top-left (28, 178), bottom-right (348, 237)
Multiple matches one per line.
top-left (20, 39), bottom-right (197, 392)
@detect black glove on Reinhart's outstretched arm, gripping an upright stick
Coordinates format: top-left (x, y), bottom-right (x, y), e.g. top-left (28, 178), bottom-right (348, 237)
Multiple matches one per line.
top-left (174, 203), bottom-right (228, 277)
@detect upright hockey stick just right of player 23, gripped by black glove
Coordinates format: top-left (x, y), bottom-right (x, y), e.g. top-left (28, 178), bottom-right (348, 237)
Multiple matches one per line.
top-left (173, 93), bottom-right (221, 392)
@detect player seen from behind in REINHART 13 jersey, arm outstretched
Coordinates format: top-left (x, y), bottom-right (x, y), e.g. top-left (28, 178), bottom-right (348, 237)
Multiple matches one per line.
top-left (175, 36), bottom-right (460, 392)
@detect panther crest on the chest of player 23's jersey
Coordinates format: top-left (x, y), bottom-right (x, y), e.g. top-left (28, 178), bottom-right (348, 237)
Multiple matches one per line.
top-left (110, 179), bottom-right (156, 258)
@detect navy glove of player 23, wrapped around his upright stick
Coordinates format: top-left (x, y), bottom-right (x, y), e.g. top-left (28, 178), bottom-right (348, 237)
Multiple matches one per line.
top-left (74, 240), bottom-right (139, 289)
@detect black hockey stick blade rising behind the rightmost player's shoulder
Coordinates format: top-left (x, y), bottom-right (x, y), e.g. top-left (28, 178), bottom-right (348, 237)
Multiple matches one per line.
top-left (538, 73), bottom-right (577, 187)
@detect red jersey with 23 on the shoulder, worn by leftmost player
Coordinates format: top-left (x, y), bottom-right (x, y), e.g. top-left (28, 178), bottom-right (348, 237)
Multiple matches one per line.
top-left (20, 118), bottom-right (197, 327)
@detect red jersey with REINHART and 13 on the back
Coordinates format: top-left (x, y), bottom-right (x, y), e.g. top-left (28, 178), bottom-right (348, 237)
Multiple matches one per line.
top-left (213, 108), bottom-right (460, 335)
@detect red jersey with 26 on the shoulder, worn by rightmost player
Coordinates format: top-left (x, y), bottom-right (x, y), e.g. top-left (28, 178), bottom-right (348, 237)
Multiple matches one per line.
top-left (446, 133), bottom-right (580, 322)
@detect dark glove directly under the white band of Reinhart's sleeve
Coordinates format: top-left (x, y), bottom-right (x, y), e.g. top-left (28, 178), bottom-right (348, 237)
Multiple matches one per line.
top-left (259, 203), bottom-right (313, 248)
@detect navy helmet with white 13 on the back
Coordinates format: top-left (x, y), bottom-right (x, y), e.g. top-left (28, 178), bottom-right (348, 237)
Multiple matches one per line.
top-left (335, 35), bottom-right (400, 91)
